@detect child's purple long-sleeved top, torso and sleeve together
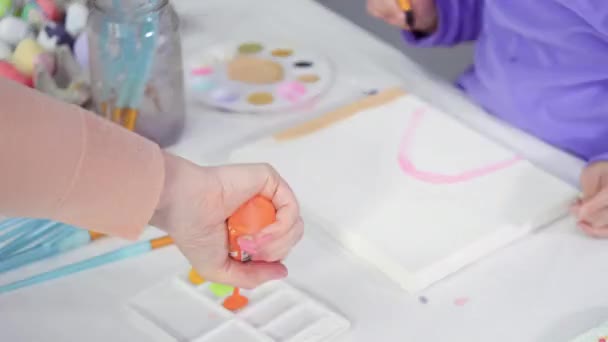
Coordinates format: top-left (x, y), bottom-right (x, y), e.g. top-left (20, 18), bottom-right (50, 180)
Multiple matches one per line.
top-left (404, 0), bottom-right (608, 162)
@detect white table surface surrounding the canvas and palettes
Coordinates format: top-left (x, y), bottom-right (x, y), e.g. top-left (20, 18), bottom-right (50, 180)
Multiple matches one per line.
top-left (0, 0), bottom-right (608, 342)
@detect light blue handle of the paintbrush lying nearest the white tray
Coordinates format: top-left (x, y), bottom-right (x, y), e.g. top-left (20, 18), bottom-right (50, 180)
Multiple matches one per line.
top-left (0, 241), bottom-right (152, 293)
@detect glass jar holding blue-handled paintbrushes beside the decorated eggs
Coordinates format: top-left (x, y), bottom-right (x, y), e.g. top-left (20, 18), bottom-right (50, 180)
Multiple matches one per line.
top-left (87, 0), bottom-right (186, 147)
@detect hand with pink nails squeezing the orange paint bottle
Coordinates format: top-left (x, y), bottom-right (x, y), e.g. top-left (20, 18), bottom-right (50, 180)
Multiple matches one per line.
top-left (151, 154), bottom-right (304, 288)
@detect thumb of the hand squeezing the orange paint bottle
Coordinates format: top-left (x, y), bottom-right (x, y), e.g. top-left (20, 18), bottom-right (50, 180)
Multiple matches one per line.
top-left (214, 260), bottom-right (287, 289)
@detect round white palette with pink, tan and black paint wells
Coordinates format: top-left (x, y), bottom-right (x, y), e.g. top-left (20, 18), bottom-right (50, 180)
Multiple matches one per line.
top-left (188, 42), bottom-right (333, 113)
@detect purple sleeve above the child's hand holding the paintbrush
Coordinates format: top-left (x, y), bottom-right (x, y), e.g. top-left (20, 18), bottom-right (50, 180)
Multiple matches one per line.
top-left (403, 0), bottom-right (485, 47)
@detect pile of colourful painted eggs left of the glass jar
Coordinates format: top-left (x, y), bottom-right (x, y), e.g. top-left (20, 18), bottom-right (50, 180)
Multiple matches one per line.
top-left (0, 0), bottom-right (91, 105)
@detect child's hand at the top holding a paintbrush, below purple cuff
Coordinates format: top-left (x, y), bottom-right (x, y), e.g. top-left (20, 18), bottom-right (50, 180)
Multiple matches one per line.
top-left (367, 0), bottom-right (437, 33)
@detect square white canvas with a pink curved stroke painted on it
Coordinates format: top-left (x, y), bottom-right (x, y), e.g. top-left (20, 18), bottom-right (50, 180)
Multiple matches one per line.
top-left (230, 95), bottom-right (576, 291)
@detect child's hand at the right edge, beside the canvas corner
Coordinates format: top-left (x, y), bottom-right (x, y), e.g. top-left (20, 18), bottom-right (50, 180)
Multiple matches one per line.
top-left (572, 162), bottom-right (608, 238)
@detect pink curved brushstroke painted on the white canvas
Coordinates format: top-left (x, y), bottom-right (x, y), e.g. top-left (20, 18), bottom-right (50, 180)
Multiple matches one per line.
top-left (398, 108), bottom-right (522, 184)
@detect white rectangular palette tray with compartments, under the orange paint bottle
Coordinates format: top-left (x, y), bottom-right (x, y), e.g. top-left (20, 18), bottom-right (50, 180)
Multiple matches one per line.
top-left (128, 276), bottom-right (350, 342)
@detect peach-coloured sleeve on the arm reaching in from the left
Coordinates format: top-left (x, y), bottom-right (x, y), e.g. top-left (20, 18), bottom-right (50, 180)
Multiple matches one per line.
top-left (0, 78), bottom-right (164, 239)
